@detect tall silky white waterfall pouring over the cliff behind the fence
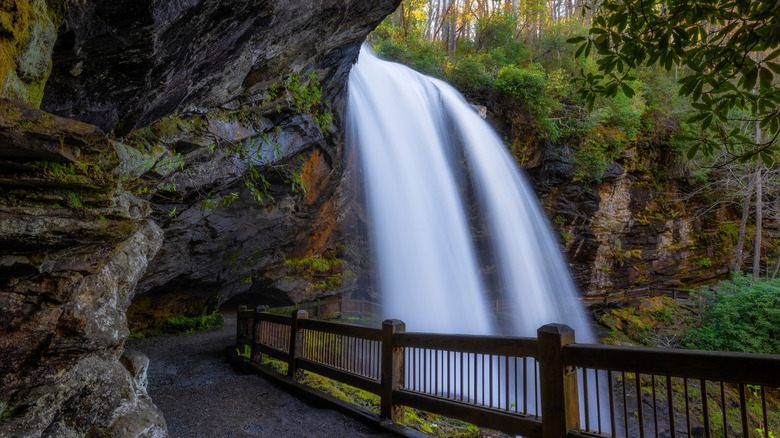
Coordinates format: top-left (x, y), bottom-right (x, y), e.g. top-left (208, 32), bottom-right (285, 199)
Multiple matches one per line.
top-left (347, 47), bottom-right (608, 430)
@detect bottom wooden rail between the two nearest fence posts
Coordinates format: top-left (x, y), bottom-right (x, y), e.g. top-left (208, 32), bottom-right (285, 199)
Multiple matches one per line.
top-left (393, 389), bottom-right (542, 438)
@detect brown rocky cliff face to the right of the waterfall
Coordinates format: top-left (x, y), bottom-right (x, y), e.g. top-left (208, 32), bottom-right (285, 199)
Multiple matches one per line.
top-left (529, 142), bottom-right (739, 297)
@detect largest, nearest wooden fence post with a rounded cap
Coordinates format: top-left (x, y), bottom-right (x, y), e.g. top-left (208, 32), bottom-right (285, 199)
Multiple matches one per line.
top-left (536, 324), bottom-right (580, 438)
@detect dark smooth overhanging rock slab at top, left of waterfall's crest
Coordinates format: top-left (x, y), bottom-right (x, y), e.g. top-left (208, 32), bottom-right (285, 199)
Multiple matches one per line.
top-left (42, 0), bottom-right (400, 134)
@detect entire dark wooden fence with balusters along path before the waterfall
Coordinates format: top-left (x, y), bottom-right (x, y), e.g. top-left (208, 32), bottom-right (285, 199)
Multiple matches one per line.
top-left (237, 308), bottom-right (780, 438)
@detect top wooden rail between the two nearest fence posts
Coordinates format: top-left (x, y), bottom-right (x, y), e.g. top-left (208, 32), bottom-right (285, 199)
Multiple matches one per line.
top-left (395, 332), bottom-right (536, 357)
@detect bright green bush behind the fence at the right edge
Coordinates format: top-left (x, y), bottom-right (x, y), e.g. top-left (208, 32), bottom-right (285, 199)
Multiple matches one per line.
top-left (685, 273), bottom-right (780, 354)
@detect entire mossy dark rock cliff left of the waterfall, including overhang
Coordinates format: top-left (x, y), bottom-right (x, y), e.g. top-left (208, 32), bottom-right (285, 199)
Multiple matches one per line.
top-left (0, 0), bottom-right (399, 437)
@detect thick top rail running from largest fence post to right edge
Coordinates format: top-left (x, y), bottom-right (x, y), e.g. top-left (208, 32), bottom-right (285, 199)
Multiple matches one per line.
top-left (563, 344), bottom-right (780, 387)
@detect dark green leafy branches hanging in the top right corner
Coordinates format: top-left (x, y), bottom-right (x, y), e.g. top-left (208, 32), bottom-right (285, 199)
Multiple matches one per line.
top-left (569, 0), bottom-right (780, 165)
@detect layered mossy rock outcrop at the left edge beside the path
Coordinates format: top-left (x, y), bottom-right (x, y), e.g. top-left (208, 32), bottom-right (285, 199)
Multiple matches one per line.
top-left (0, 101), bottom-right (166, 437)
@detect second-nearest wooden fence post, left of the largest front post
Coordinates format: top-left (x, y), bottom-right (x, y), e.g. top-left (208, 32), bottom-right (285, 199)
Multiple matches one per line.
top-left (379, 319), bottom-right (406, 424)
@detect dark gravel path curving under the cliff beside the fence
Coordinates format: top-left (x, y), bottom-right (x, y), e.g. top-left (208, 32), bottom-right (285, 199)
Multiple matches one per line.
top-left (127, 312), bottom-right (392, 438)
